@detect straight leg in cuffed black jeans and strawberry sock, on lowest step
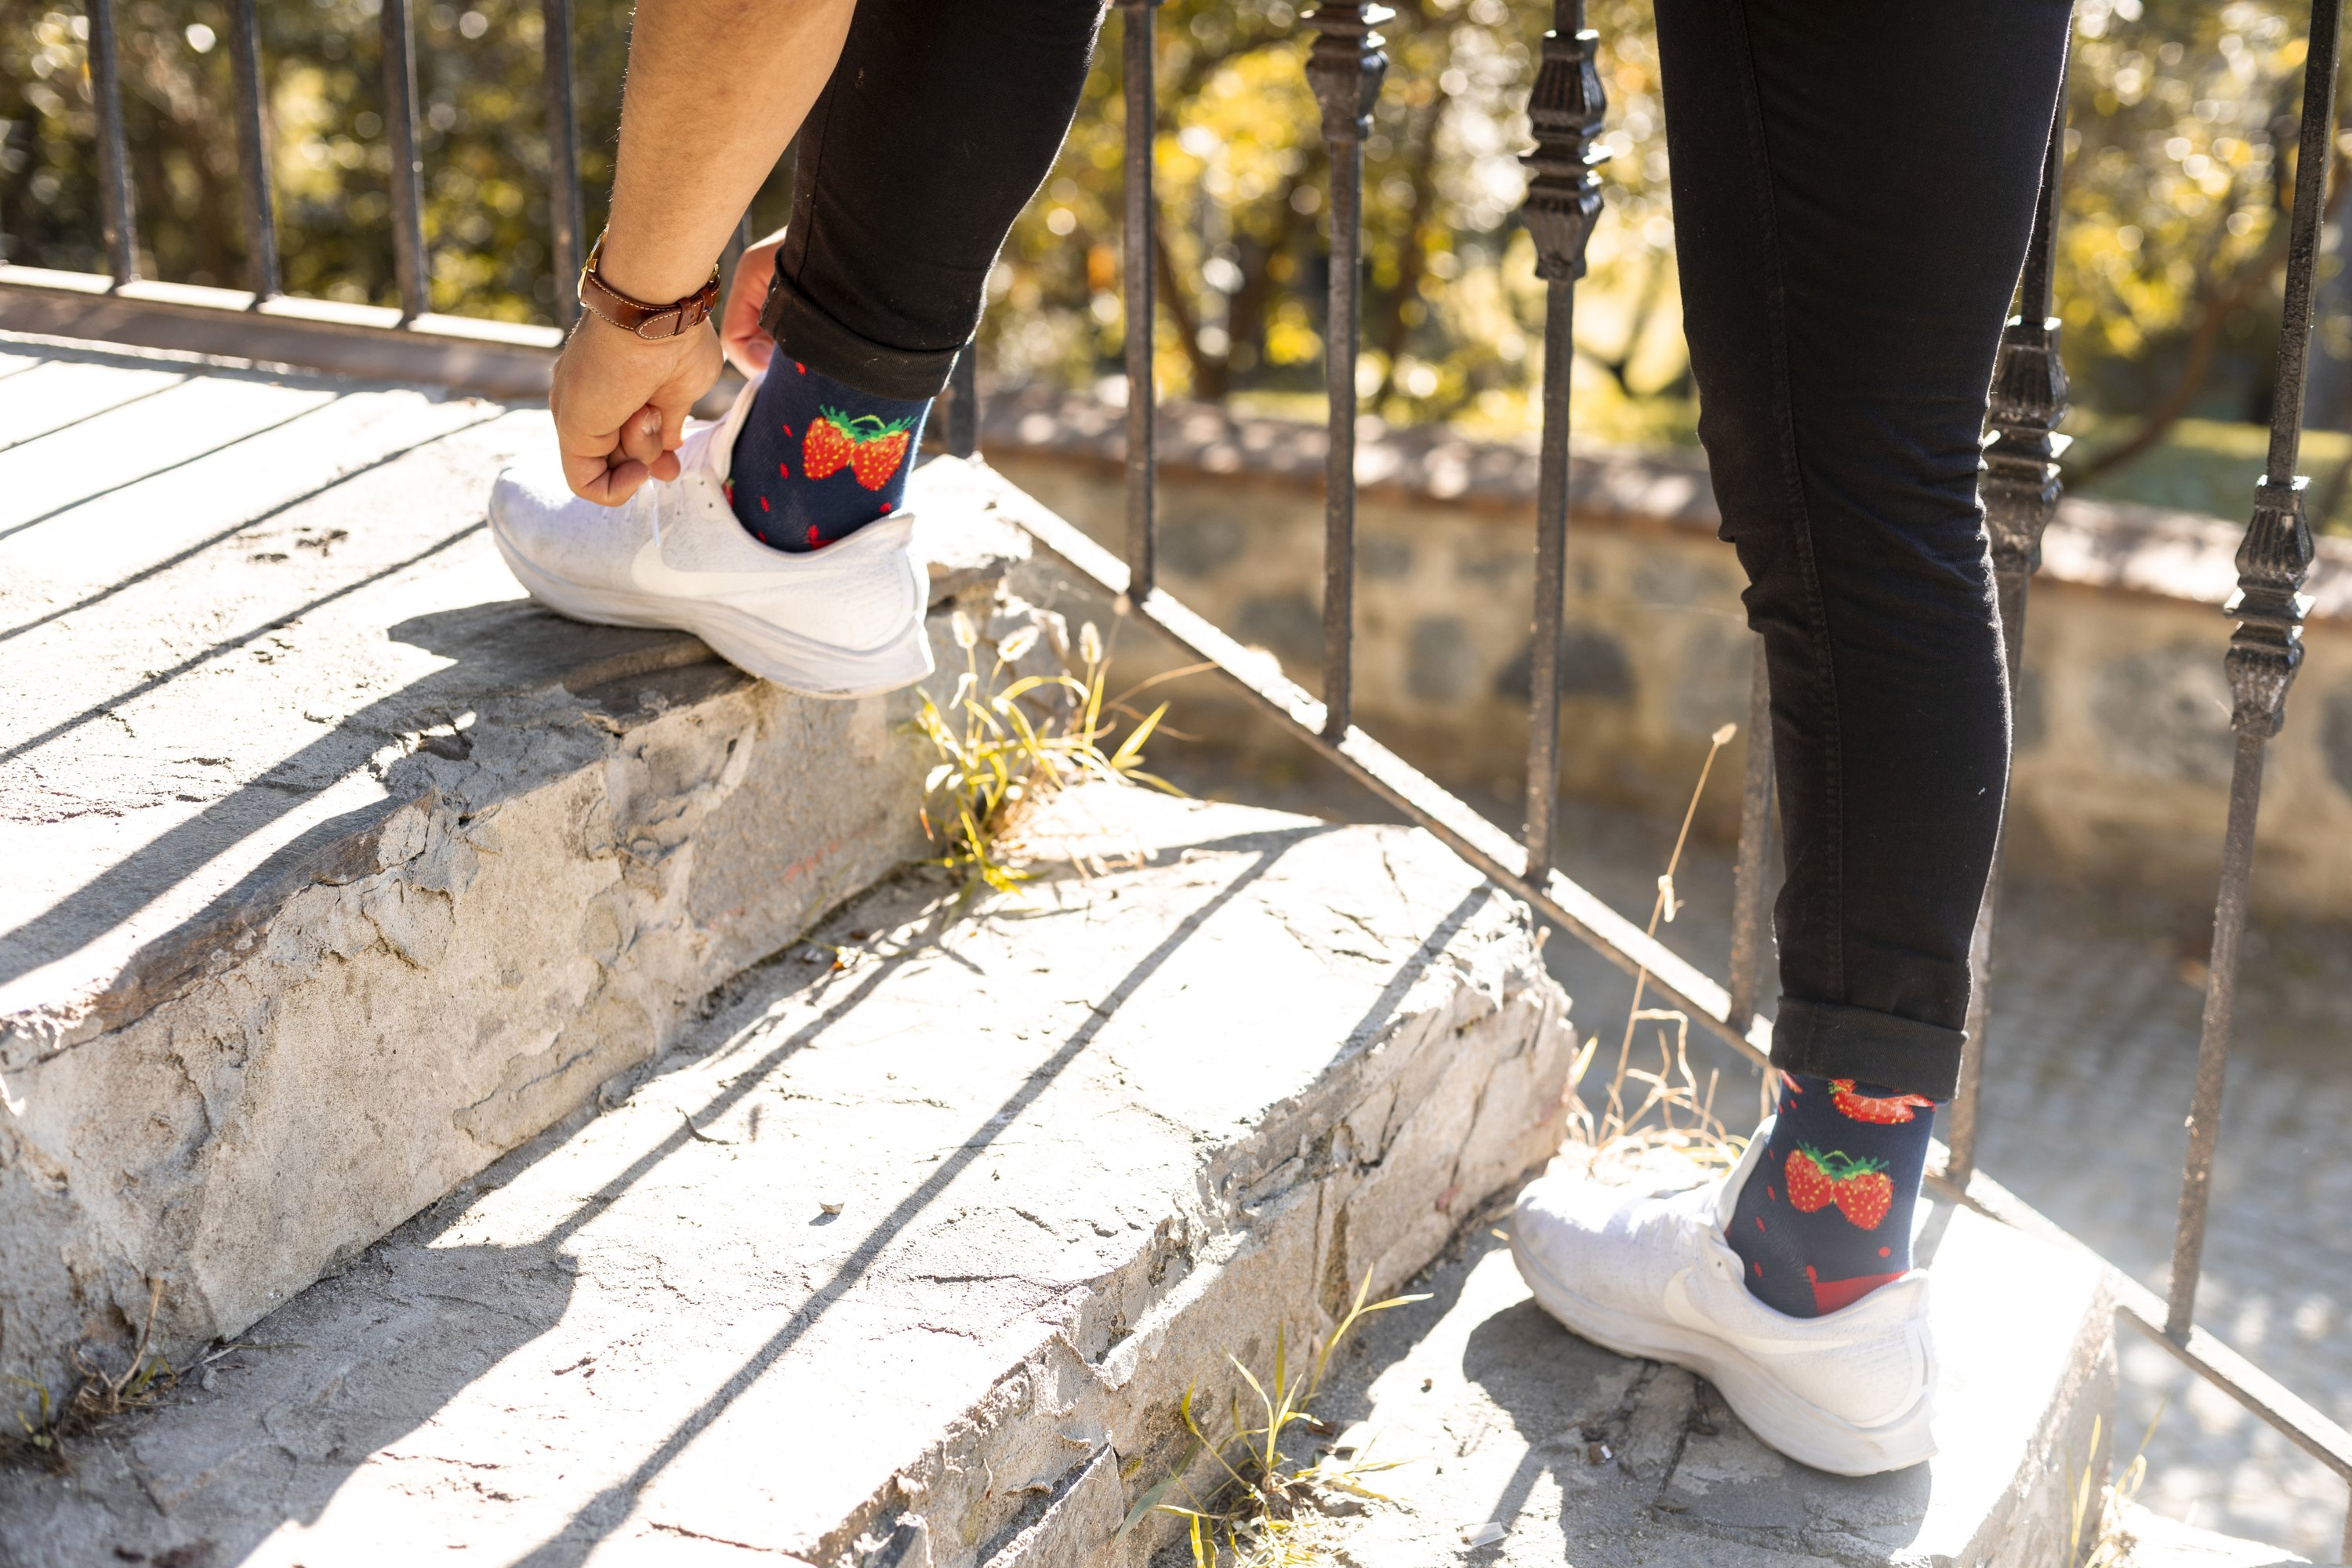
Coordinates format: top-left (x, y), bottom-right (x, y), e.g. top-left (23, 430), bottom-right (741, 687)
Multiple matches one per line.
top-left (1658, 0), bottom-right (2067, 1316)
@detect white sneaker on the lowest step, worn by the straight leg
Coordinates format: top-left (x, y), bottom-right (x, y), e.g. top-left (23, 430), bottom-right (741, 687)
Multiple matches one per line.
top-left (1510, 1121), bottom-right (1936, 1476)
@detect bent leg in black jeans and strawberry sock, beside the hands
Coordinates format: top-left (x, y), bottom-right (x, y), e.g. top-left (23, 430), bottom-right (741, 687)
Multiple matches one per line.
top-left (729, 0), bottom-right (1103, 550)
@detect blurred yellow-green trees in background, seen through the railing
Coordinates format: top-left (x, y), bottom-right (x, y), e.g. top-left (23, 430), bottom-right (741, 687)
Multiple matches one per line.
top-left (0, 0), bottom-right (2352, 521)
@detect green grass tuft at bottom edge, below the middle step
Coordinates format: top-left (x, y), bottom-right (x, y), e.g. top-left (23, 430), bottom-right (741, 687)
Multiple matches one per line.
top-left (1138, 1269), bottom-right (1430, 1568)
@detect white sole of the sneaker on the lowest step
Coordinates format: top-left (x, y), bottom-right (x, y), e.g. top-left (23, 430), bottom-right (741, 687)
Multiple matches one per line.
top-left (1510, 1236), bottom-right (1936, 1476)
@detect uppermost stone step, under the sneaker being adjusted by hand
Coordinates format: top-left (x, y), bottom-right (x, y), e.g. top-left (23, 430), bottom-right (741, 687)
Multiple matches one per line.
top-left (0, 334), bottom-right (1025, 1406)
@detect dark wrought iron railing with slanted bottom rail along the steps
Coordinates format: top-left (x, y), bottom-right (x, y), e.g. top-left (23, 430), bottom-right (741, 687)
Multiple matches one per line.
top-left (13, 0), bottom-right (2352, 1556)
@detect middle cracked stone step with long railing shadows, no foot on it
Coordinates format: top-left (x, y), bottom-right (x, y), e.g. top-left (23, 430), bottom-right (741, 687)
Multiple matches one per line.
top-left (0, 787), bottom-right (1571, 1568)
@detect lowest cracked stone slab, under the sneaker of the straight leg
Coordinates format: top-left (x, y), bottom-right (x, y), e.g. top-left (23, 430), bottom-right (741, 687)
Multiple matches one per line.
top-left (1279, 1171), bottom-right (2126, 1568)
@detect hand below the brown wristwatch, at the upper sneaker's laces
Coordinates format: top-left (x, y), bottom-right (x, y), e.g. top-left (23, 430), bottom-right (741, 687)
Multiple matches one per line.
top-left (548, 310), bottom-right (720, 506)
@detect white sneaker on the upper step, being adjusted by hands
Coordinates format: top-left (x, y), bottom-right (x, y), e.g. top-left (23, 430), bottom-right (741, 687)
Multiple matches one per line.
top-left (489, 379), bottom-right (931, 696)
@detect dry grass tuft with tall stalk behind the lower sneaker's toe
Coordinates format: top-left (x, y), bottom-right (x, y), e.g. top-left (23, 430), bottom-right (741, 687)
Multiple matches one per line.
top-left (1566, 724), bottom-right (1769, 1178)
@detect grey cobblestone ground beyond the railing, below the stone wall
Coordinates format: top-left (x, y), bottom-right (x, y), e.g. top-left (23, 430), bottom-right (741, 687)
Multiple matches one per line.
top-left (1155, 753), bottom-right (2352, 1561)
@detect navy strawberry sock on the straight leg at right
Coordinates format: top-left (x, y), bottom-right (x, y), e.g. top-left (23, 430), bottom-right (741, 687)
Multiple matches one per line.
top-left (1724, 1072), bottom-right (1936, 1316)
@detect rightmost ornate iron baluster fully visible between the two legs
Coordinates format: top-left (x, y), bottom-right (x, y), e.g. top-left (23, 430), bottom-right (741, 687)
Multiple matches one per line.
top-left (1519, 0), bottom-right (1609, 881)
